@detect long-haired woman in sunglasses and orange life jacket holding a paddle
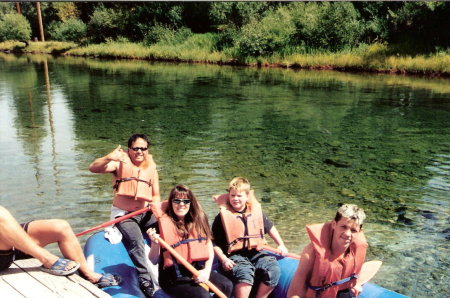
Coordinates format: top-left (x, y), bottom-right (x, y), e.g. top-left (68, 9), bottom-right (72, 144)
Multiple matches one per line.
top-left (147, 184), bottom-right (233, 298)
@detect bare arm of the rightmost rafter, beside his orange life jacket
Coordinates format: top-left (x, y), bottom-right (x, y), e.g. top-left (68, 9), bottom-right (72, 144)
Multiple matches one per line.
top-left (287, 243), bottom-right (315, 298)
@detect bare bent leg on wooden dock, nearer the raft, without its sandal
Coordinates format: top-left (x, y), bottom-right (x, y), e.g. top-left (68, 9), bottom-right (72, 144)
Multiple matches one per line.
top-left (27, 219), bottom-right (102, 283)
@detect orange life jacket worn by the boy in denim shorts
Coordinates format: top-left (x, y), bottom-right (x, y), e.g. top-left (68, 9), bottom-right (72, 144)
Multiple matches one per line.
top-left (214, 191), bottom-right (266, 254)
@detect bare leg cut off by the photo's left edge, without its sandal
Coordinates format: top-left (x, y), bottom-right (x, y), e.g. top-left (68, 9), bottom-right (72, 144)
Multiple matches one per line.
top-left (0, 206), bottom-right (58, 268)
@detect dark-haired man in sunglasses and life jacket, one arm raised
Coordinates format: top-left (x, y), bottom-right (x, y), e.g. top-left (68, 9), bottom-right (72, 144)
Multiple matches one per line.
top-left (89, 134), bottom-right (161, 297)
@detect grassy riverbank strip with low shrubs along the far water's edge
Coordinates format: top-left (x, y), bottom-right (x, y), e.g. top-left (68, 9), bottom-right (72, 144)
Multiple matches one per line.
top-left (0, 39), bottom-right (450, 77)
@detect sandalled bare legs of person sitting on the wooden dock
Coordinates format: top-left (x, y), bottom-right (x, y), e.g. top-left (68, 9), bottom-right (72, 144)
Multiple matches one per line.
top-left (0, 206), bottom-right (121, 288)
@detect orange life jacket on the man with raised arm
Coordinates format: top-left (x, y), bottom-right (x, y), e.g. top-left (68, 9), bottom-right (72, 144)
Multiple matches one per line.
top-left (113, 160), bottom-right (156, 200)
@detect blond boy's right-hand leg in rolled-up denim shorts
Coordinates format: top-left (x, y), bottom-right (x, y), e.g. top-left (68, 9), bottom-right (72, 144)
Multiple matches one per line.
top-left (252, 254), bottom-right (281, 298)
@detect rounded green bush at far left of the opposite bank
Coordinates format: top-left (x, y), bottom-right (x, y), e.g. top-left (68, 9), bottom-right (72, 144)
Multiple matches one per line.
top-left (0, 13), bottom-right (31, 42)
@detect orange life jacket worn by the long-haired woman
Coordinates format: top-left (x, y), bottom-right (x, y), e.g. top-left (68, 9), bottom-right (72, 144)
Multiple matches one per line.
top-left (152, 200), bottom-right (209, 268)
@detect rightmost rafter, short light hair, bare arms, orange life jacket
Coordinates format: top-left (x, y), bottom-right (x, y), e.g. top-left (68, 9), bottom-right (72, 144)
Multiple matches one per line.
top-left (288, 204), bottom-right (367, 298)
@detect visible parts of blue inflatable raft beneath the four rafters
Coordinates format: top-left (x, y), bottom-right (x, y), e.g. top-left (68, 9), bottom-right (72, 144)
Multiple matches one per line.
top-left (84, 231), bottom-right (406, 298)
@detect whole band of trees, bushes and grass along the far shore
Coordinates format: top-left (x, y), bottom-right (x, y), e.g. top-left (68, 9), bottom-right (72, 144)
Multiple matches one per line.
top-left (0, 1), bottom-right (450, 77)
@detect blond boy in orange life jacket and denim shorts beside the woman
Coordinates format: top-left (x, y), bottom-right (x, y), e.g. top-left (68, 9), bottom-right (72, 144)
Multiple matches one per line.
top-left (212, 177), bottom-right (288, 298)
